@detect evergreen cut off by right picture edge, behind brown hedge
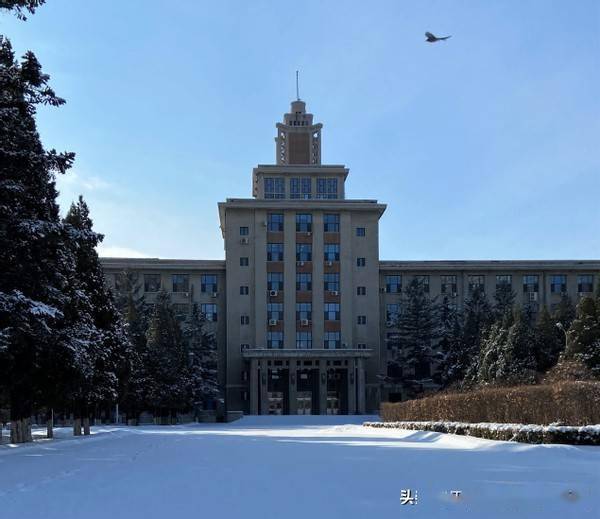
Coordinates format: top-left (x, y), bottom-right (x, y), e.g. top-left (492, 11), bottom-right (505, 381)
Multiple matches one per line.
top-left (566, 297), bottom-right (600, 377)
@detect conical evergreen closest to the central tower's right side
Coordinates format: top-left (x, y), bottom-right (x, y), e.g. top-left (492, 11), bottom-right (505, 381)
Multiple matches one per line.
top-left (395, 278), bottom-right (438, 380)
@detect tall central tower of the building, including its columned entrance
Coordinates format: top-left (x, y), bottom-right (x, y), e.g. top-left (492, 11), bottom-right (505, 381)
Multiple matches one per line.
top-left (219, 99), bottom-right (385, 414)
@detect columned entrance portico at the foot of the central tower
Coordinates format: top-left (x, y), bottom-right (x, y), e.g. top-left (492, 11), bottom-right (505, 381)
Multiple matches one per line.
top-left (243, 349), bottom-right (371, 414)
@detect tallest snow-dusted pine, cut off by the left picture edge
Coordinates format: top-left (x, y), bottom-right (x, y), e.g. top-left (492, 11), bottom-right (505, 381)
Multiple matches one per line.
top-left (0, 36), bottom-right (83, 441)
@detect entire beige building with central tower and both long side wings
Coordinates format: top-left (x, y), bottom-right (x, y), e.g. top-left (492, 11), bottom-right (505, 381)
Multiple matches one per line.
top-left (102, 99), bottom-right (600, 414)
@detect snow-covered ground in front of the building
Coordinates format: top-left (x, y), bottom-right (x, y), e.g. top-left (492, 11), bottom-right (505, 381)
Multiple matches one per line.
top-left (0, 416), bottom-right (600, 519)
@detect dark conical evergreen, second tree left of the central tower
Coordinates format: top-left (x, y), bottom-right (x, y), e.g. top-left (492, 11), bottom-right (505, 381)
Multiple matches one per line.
top-left (145, 291), bottom-right (192, 418)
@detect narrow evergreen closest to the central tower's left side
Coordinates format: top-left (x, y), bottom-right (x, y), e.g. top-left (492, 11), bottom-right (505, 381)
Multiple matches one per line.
top-left (183, 304), bottom-right (219, 409)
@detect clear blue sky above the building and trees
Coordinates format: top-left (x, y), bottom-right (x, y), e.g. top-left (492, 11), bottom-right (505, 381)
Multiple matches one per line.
top-left (0, 0), bottom-right (600, 260)
